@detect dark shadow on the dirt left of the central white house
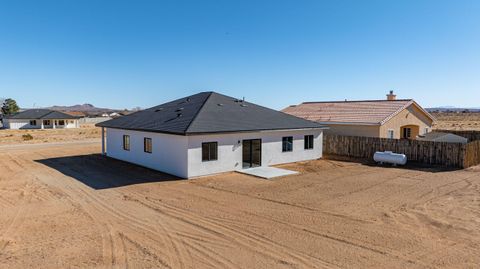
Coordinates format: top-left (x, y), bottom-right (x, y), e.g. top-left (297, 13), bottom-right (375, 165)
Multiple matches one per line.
top-left (35, 154), bottom-right (181, 190)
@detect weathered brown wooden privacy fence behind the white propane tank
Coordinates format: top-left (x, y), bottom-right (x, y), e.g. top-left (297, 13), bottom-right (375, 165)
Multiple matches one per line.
top-left (323, 135), bottom-right (480, 168)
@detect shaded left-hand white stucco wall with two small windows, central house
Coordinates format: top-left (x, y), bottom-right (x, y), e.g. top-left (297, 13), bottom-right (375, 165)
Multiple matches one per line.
top-left (106, 129), bottom-right (188, 178)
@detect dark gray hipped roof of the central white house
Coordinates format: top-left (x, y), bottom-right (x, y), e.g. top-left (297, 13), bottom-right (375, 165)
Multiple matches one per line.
top-left (97, 92), bottom-right (326, 135)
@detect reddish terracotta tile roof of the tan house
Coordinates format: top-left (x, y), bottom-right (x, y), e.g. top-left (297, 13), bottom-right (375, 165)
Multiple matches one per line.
top-left (282, 99), bottom-right (423, 125)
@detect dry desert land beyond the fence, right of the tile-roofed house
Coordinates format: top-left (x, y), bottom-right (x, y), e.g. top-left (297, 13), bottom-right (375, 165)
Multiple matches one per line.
top-left (432, 113), bottom-right (480, 131)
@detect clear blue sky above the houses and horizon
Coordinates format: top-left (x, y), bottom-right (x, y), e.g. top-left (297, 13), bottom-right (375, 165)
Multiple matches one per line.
top-left (0, 0), bottom-right (480, 109)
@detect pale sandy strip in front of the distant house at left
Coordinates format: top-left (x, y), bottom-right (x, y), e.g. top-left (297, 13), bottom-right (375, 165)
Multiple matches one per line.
top-left (0, 124), bottom-right (101, 145)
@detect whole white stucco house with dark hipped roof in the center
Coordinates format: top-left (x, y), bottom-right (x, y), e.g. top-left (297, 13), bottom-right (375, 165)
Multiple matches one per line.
top-left (97, 92), bottom-right (325, 178)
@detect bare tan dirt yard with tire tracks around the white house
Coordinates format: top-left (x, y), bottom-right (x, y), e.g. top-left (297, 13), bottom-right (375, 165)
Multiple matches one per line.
top-left (0, 142), bottom-right (480, 268)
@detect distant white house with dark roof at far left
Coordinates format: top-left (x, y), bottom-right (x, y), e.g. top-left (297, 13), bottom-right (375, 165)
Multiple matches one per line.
top-left (3, 109), bottom-right (79, 129)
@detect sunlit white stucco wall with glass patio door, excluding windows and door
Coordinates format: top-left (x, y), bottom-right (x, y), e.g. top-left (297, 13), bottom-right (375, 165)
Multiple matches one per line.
top-left (188, 130), bottom-right (323, 177)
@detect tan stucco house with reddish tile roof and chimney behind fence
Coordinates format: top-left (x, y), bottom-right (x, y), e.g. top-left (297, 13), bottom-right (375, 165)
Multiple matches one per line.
top-left (283, 91), bottom-right (435, 139)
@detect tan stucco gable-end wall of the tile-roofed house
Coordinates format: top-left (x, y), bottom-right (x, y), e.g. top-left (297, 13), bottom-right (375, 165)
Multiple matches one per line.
top-left (380, 105), bottom-right (432, 139)
